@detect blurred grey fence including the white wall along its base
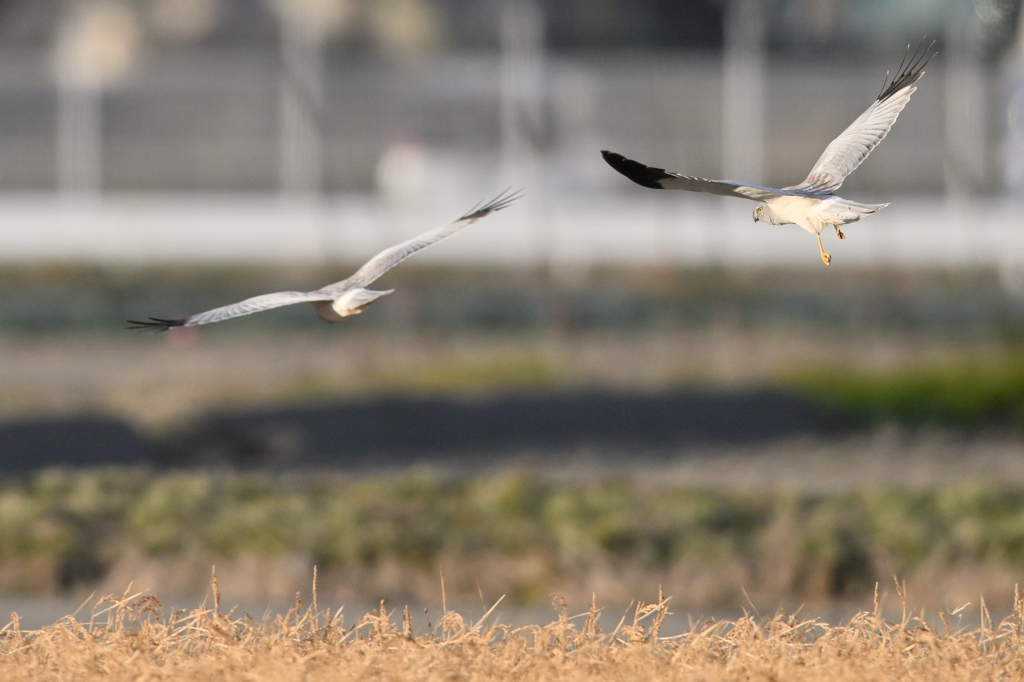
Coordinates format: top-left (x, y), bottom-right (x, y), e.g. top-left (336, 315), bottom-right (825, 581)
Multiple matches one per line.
top-left (0, 51), bottom-right (1024, 266)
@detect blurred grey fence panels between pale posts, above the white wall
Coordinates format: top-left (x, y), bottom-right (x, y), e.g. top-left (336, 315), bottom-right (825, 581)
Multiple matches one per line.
top-left (0, 52), bottom-right (991, 194)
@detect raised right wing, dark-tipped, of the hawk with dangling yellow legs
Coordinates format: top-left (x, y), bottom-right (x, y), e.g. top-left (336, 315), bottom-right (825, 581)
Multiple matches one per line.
top-left (785, 42), bottom-right (935, 194)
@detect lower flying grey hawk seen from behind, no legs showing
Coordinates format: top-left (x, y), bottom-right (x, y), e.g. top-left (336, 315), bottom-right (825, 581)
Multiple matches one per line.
top-left (128, 189), bottom-right (521, 332)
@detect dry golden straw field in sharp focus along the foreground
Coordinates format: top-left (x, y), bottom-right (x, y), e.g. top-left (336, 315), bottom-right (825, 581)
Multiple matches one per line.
top-left (0, 578), bottom-right (1024, 682)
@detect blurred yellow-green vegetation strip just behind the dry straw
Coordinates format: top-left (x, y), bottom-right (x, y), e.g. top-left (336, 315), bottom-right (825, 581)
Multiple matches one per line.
top-left (0, 469), bottom-right (1024, 597)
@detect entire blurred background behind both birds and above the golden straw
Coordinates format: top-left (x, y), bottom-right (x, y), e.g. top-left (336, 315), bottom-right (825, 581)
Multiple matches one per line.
top-left (0, 0), bottom-right (1024, 614)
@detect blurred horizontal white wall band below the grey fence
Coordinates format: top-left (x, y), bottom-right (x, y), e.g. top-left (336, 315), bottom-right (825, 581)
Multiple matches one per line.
top-left (0, 187), bottom-right (1011, 271)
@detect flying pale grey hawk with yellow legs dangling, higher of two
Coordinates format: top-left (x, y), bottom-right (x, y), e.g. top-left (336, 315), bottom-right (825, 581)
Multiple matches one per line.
top-left (601, 43), bottom-right (934, 265)
